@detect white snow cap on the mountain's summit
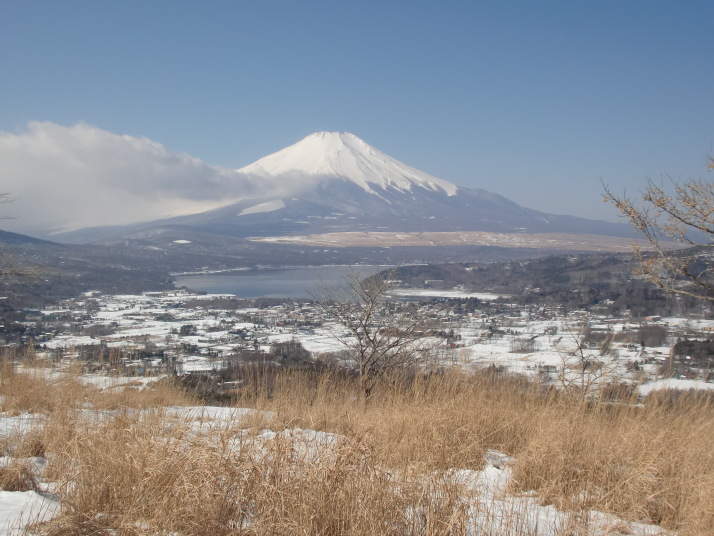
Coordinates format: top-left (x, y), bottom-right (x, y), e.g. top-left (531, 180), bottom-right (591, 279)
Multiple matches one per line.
top-left (238, 131), bottom-right (458, 195)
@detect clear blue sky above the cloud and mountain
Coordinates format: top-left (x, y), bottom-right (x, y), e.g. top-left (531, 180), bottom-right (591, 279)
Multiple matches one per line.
top-left (0, 0), bottom-right (714, 234)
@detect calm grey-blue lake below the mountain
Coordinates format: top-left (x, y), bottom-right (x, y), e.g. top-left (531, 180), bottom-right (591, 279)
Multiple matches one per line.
top-left (175, 266), bottom-right (389, 299)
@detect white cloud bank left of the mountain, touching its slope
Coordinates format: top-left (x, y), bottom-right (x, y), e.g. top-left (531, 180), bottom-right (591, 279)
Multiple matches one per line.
top-left (0, 122), bottom-right (274, 236)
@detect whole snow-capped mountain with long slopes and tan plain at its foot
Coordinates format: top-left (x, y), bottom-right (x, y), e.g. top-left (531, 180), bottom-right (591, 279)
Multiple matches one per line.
top-left (55, 132), bottom-right (631, 264)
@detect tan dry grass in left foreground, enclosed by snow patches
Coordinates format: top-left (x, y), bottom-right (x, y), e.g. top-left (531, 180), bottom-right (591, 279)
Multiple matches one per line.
top-left (34, 413), bottom-right (468, 536)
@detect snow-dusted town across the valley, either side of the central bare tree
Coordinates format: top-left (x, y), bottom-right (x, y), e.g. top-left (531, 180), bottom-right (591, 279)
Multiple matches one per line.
top-left (18, 282), bottom-right (714, 400)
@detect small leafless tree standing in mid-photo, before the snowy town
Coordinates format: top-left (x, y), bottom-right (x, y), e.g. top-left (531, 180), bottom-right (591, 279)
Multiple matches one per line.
top-left (314, 268), bottom-right (441, 399)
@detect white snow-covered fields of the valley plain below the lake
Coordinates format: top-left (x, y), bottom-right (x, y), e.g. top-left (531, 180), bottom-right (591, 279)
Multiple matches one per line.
top-left (38, 289), bottom-right (714, 396)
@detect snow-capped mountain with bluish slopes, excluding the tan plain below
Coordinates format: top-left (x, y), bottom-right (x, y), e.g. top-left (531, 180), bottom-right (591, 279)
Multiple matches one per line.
top-left (163, 132), bottom-right (628, 236)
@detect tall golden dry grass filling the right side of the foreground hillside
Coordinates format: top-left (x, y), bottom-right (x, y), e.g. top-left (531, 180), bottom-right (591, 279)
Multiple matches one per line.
top-left (246, 372), bottom-right (714, 534)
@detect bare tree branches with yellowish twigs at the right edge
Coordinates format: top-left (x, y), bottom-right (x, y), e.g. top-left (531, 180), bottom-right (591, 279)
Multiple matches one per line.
top-left (604, 158), bottom-right (714, 301)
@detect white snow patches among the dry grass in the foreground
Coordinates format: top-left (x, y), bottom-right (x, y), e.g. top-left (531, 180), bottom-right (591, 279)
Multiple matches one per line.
top-left (0, 406), bottom-right (672, 536)
